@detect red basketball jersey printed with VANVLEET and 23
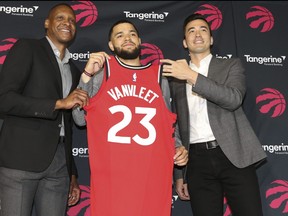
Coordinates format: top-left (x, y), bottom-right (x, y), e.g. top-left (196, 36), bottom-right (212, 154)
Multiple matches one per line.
top-left (85, 56), bottom-right (176, 216)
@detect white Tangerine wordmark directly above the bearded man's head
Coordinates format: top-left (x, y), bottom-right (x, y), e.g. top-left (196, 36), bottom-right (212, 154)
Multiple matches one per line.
top-left (123, 11), bottom-right (169, 22)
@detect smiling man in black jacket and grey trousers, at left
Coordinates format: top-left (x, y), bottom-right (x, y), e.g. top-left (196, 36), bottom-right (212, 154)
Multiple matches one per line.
top-left (0, 4), bottom-right (86, 216)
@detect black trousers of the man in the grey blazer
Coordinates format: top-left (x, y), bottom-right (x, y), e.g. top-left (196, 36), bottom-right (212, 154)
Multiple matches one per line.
top-left (187, 144), bottom-right (263, 216)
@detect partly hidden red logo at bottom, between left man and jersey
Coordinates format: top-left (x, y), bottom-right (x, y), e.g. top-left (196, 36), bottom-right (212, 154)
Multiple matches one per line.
top-left (67, 185), bottom-right (90, 216)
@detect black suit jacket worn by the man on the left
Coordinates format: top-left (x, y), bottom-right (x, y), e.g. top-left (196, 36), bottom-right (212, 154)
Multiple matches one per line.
top-left (0, 38), bottom-right (80, 175)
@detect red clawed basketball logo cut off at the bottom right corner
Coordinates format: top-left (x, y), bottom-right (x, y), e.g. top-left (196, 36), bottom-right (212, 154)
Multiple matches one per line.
top-left (266, 180), bottom-right (288, 214)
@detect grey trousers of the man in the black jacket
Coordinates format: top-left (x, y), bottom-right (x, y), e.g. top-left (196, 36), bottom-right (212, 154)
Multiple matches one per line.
top-left (0, 143), bottom-right (70, 216)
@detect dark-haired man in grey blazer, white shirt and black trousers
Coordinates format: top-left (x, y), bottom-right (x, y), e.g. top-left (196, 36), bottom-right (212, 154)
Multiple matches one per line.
top-left (162, 14), bottom-right (266, 216)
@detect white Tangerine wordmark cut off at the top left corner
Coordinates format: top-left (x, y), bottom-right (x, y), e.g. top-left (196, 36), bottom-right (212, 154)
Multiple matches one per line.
top-left (0, 5), bottom-right (39, 17)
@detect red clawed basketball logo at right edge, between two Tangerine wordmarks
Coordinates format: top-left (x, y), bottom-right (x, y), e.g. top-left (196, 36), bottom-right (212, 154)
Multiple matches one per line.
top-left (256, 88), bottom-right (286, 118)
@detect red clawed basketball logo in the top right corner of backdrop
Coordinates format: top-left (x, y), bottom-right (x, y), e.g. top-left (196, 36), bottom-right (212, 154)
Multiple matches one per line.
top-left (246, 6), bottom-right (274, 32)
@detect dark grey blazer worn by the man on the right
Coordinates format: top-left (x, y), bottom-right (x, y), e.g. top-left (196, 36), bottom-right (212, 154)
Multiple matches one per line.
top-left (170, 57), bottom-right (266, 179)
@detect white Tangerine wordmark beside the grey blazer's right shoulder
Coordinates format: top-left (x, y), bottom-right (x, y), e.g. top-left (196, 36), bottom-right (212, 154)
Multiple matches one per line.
top-left (244, 55), bottom-right (286, 67)
